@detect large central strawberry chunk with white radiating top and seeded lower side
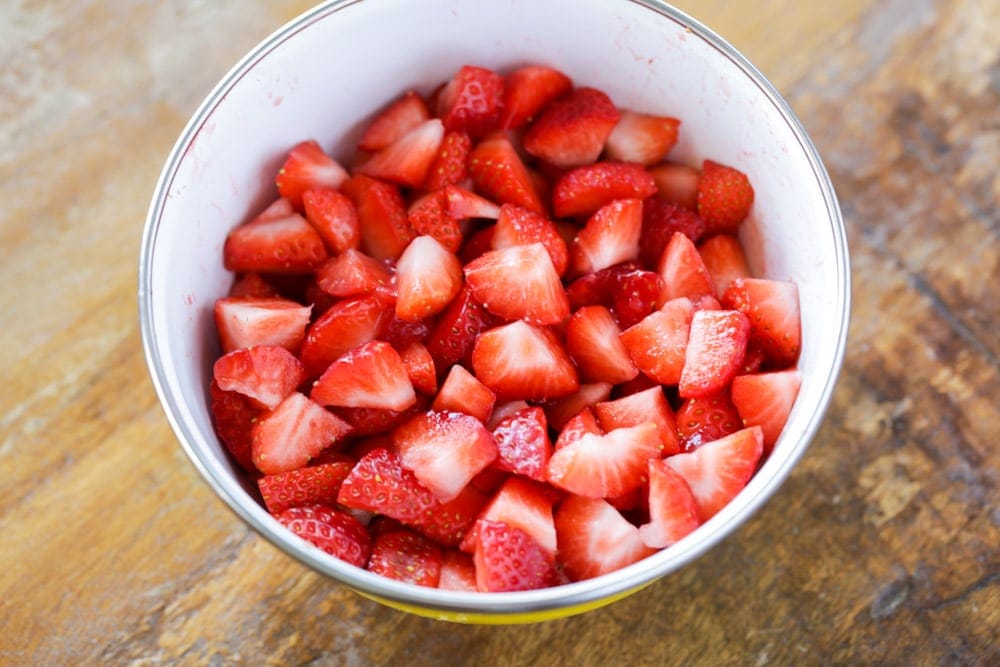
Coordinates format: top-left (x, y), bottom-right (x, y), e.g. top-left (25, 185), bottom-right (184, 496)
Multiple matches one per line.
top-left (472, 322), bottom-right (580, 401)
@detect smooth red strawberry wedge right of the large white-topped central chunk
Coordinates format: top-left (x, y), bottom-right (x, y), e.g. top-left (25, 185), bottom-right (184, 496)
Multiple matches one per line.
top-left (566, 305), bottom-right (639, 384)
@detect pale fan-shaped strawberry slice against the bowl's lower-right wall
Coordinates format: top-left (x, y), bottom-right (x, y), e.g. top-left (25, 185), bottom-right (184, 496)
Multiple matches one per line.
top-left (664, 426), bottom-right (764, 523)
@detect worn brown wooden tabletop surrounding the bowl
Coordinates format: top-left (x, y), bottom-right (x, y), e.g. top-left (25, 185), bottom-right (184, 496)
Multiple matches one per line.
top-left (0, 0), bottom-right (1000, 665)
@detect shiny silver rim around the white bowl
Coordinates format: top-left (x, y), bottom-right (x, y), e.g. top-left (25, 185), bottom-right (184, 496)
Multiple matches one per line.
top-left (138, 0), bottom-right (851, 620)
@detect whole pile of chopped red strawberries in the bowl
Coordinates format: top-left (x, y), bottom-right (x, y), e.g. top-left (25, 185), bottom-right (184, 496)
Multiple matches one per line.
top-left (209, 66), bottom-right (800, 591)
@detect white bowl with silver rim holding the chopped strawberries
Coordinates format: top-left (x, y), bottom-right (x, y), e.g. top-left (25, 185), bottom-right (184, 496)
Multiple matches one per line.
top-left (139, 0), bottom-right (850, 623)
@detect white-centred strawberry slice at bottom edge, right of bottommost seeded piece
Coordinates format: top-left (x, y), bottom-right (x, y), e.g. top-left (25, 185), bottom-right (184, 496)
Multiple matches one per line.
top-left (555, 496), bottom-right (656, 581)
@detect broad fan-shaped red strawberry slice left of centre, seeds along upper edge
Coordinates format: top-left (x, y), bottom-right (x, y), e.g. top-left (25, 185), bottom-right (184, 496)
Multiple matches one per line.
top-left (310, 340), bottom-right (417, 412)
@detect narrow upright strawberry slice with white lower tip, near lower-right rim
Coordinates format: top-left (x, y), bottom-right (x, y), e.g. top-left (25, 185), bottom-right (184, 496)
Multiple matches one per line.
top-left (639, 459), bottom-right (700, 549)
